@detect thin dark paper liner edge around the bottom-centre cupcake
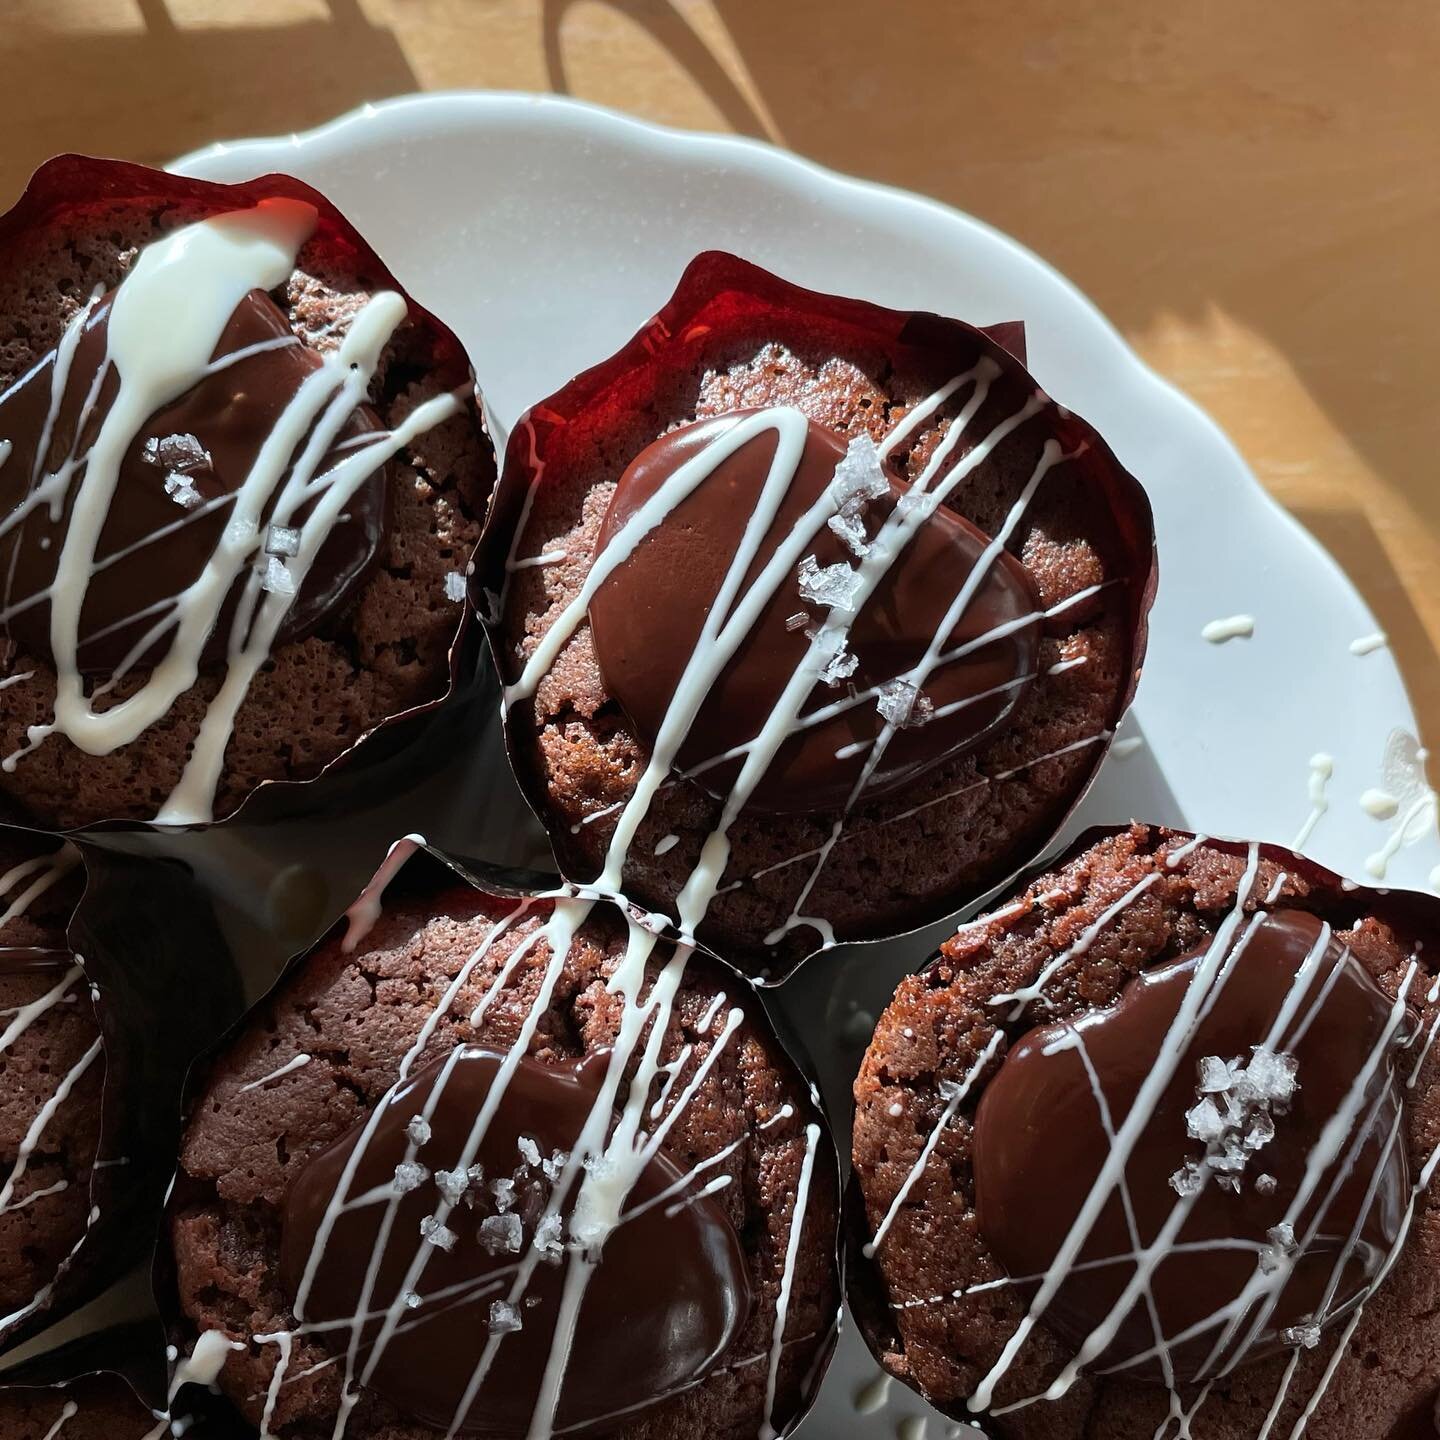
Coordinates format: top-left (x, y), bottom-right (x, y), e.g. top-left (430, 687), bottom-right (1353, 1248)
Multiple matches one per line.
top-left (157, 840), bottom-right (844, 1436)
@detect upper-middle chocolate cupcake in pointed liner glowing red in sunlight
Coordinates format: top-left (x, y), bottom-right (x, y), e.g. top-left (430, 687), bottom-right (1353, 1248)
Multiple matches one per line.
top-left (477, 253), bottom-right (1153, 975)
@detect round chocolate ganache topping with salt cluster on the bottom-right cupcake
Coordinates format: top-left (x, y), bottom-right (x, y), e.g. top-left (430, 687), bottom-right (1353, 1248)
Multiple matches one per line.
top-left (975, 912), bottom-right (1410, 1382)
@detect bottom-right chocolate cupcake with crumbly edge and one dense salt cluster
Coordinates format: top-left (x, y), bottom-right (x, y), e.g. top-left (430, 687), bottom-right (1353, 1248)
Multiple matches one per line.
top-left (852, 825), bottom-right (1440, 1440)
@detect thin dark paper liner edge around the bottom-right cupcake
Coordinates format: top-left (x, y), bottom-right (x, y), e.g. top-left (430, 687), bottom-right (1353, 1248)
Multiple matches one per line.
top-left (841, 822), bottom-right (1440, 1433)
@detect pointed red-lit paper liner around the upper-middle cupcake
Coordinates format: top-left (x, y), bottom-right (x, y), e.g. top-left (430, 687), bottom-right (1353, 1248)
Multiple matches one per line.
top-left (471, 251), bottom-right (1158, 985)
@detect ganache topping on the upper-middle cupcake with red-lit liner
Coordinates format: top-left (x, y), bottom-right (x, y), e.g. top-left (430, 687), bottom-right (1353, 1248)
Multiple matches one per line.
top-left (589, 410), bottom-right (1041, 812)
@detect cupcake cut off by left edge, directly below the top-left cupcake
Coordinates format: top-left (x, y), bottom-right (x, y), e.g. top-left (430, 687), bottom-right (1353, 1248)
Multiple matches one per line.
top-left (0, 828), bottom-right (105, 1336)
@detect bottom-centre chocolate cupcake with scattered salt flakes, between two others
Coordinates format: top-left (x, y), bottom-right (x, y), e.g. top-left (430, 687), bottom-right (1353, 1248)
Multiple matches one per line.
top-left (171, 852), bottom-right (838, 1440)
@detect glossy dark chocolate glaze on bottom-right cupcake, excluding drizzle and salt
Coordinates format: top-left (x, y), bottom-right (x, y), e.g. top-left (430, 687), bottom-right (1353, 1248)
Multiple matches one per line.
top-left (975, 912), bottom-right (1410, 1382)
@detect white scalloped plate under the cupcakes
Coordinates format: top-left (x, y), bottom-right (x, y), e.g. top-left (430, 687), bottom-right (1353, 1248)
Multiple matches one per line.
top-left (176, 94), bottom-right (1440, 1440)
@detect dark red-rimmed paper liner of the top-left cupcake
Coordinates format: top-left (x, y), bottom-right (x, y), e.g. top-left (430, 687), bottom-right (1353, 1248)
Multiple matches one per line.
top-left (0, 154), bottom-right (494, 834)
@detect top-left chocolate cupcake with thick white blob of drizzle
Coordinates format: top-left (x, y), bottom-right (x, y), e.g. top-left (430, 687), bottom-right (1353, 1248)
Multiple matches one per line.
top-left (0, 156), bottom-right (494, 828)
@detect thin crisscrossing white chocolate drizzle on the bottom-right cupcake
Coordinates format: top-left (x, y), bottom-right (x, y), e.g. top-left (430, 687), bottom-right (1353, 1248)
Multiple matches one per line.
top-left (867, 837), bottom-right (1440, 1440)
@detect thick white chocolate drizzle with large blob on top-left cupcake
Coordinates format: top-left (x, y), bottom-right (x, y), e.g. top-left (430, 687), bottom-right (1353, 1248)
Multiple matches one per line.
top-left (0, 208), bottom-right (461, 825)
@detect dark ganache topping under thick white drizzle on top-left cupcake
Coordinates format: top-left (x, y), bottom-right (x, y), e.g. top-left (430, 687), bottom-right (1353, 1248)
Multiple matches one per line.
top-left (0, 289), bottom-right (386, 675)
